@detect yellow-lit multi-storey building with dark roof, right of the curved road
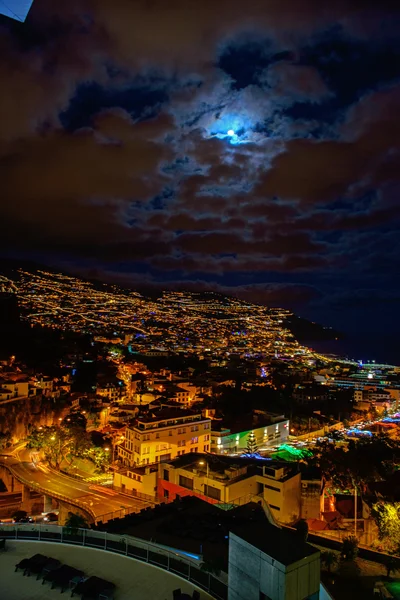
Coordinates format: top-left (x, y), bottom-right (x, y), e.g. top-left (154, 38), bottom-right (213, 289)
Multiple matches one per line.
top-left (118, 408), bottom-right (211, 467)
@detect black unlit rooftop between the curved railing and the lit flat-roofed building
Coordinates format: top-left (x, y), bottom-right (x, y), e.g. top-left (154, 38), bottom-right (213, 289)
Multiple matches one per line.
top-left (97, 496), bottom-right (318, 571)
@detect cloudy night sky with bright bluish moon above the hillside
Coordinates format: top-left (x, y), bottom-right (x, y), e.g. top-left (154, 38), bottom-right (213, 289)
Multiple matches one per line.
top-left (0, 0), bottom-right (400, 358)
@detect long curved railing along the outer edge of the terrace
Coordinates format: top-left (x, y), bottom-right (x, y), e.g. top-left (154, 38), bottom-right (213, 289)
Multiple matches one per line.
top-left (0, 525), bottom-right (228, 600)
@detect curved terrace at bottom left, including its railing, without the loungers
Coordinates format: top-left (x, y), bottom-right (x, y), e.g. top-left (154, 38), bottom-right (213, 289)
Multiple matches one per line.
top-left (0, 526), bottom-right (218, 600)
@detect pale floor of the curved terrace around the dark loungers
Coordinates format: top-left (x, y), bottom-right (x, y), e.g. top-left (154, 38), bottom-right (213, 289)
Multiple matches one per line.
top-left (0, 540), bottom-right (212, 600)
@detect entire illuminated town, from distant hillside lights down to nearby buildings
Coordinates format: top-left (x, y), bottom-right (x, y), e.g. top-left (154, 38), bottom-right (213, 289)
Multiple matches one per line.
top-left (0, 270), bottom-right (400, 599)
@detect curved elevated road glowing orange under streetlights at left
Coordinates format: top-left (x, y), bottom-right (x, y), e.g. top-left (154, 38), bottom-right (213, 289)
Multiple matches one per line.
top-left (1, 449), bottom-right (149, 520)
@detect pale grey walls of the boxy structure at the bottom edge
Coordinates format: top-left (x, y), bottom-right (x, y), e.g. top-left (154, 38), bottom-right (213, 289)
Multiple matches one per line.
top-left (228, 533), bottom-right (320, 600)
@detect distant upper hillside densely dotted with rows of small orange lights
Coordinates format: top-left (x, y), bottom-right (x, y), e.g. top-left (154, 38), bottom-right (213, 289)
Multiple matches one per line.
top-left (17, 271), bottom-right (308, 358)
